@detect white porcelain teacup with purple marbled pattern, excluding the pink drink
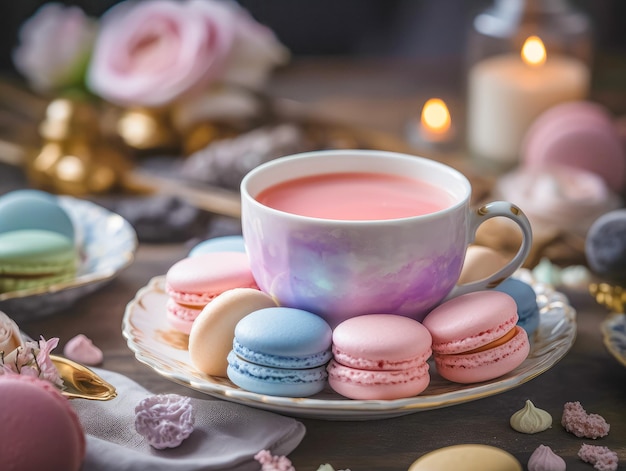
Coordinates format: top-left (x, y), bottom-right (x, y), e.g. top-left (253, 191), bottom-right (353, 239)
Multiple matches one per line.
top-left (241, 150), bottom-right (532, 327)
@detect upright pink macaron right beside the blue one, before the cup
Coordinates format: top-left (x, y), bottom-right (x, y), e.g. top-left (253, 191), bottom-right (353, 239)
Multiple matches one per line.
top-left (327, 314), bottom-right (432, 400)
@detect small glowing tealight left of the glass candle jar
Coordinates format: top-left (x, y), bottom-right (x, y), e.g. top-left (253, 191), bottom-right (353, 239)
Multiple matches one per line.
top-left (409, 98), bottom-right (454, 147)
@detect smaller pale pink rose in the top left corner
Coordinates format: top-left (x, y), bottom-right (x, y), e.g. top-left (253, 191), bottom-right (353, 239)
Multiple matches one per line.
top-left (13, 3), bottom-right (97, 92)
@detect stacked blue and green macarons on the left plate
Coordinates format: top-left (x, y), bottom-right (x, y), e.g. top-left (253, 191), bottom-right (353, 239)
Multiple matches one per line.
top-left (0, 190), bottom-right (79, 293)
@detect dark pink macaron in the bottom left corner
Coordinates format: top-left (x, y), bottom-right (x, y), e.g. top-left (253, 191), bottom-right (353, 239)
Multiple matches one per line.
top-left (0, 373), bottom-right (86, 471)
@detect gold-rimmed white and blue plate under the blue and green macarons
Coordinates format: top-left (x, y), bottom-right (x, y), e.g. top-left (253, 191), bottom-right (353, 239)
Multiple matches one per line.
top-left (0, 196), bottom-right (137, 324)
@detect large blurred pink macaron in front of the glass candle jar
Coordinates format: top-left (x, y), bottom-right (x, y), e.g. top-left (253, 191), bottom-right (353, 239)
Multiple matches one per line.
top-left (521, 101), bottom-right (626, 194)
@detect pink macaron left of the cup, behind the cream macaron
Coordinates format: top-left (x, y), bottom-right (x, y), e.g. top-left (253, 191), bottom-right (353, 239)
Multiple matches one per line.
top-left (165, 252), bottom-right (258, 334)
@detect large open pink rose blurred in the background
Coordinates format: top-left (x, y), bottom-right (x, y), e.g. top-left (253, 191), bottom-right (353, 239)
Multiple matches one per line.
top-left (88, 0), bottom-right (285, 106)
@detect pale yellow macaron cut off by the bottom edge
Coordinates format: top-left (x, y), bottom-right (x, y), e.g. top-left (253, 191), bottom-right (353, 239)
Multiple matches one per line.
top-left (408, 444), bottom-right (522, 471)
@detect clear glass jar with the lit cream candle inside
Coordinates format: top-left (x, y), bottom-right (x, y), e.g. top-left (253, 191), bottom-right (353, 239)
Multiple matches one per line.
top-left (467, 0), bottom-right (593, 168)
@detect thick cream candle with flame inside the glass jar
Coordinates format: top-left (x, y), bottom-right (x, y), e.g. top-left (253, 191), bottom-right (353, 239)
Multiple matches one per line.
top-left (467, 36), bottom-right (590, 165)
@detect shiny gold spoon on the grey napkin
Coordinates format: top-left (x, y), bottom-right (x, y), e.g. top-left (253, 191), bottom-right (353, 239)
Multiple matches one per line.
top-left (50, 355), bottom-right (117, 401)
